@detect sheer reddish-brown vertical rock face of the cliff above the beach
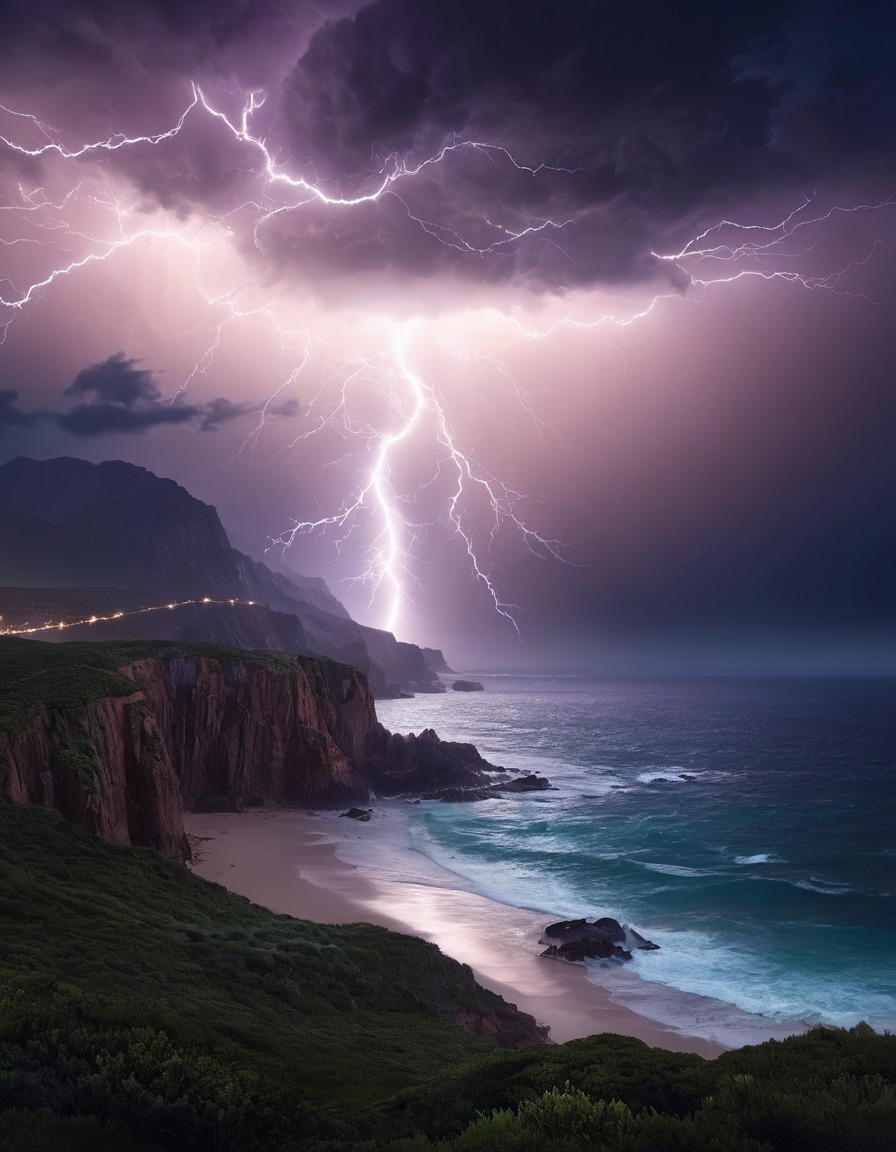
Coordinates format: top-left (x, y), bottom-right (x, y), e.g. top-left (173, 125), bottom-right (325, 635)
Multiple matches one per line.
top-left (0, 652), bottom-right (382, 858)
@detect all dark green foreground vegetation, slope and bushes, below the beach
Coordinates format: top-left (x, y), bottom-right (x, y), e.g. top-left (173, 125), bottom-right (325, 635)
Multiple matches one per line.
top-left (0, 802), bottom-right (896, 1152)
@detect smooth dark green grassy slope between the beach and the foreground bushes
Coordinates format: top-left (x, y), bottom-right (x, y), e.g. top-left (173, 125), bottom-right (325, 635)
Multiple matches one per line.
top-left (0, 802), bottom-right (496, 1102)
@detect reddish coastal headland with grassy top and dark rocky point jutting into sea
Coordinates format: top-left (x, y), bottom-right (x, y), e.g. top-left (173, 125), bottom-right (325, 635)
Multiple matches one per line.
top-left (0, 637), bottom-right (495, 859)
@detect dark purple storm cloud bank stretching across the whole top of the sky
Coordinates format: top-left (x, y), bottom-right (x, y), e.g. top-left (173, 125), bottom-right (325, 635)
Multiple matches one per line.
top-left (0, 0), bottom-right (896, 291)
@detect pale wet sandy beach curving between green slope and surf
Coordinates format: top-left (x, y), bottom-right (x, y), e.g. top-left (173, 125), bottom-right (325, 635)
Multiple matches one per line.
top-left (185, 809), bottom-right (724, 1056)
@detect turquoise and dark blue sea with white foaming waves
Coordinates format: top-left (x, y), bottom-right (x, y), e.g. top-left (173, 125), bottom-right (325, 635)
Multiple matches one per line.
top-left (378, 673), bottom-right (896, 1045)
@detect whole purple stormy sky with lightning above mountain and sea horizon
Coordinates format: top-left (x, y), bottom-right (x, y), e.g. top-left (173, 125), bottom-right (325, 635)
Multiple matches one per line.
top-left (0, 0), bottom-right (896, 672)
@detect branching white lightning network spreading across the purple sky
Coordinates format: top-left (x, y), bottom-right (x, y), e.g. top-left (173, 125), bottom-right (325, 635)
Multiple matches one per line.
top-left (0, 84), bottom-right (896, 634)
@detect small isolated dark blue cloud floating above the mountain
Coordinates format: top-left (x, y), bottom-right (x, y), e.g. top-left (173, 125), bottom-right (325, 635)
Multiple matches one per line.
top-left (54, 353), bottom-right (299, 437)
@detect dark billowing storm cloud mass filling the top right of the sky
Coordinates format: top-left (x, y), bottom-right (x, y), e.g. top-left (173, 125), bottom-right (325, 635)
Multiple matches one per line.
top-left (261, 0), bottom-right (895, 288)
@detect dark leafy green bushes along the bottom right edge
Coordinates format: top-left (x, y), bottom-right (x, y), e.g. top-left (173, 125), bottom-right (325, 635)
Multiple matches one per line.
top-left (390, 1024), bottom-right (896, 1152)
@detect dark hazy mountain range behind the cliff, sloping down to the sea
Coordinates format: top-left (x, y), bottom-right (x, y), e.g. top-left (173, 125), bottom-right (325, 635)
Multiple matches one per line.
top-left (0, 456), bottom-right (443, 697)
